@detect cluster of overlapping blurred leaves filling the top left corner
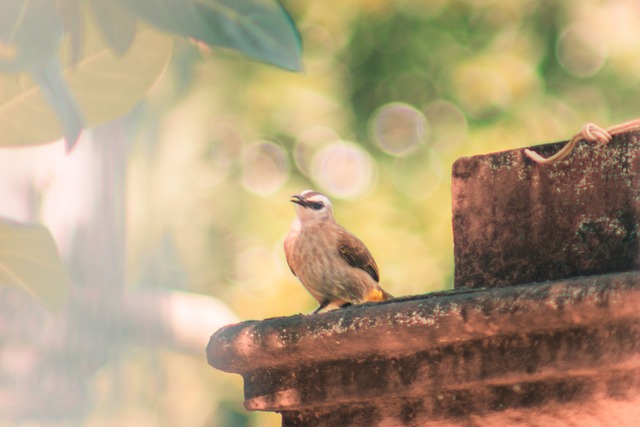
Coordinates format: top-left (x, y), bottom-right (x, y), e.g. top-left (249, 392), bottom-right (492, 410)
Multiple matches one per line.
top-left (0, 0), bottom-right (301, 150)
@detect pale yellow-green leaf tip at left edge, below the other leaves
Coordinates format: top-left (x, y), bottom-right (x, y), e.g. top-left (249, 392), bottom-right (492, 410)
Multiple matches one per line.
top-left (0, 219), bottom-right (69, 310)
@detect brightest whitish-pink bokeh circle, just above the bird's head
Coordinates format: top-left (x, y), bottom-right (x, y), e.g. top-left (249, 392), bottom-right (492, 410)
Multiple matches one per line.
top-left (311, 141), bottom-right (376, 198)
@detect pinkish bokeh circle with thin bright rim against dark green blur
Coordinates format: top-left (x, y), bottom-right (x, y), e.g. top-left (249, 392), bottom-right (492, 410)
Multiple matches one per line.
top-left (369, 102), bottom-right (427, 156)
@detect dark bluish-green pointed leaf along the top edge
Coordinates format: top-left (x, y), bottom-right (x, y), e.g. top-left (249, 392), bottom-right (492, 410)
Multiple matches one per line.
top-left (118, 0), bottom-right (302, 71)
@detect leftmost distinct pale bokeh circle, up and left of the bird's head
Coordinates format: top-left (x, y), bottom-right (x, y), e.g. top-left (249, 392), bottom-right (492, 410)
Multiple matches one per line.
top-left (242, 141), bottom-right (289, 196)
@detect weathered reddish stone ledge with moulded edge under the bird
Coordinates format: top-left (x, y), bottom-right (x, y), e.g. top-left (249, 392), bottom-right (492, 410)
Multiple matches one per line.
top-left (207, 272), bottom-right (640, 426)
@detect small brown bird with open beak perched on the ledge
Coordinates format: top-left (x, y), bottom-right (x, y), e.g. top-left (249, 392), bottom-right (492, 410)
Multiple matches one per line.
top-left (284, 190), bottom-right (393, 314)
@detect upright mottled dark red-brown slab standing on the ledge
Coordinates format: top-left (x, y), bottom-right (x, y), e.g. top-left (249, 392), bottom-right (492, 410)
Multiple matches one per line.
top-left (452, 132), bottom-right (640, 288)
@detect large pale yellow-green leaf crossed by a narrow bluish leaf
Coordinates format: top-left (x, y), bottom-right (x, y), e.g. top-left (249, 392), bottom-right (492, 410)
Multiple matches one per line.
top-left (0, 20), bottom-right (173, 146)
